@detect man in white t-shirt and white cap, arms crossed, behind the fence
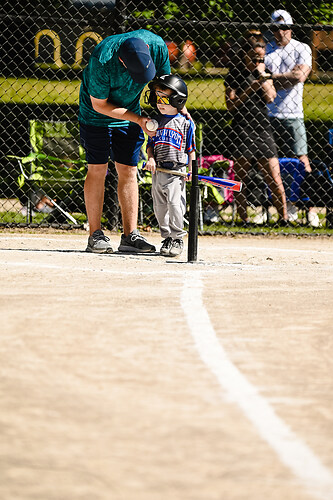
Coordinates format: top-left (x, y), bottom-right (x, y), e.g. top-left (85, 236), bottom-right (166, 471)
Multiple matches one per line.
top-left (265, 9), bottom-right (319, 226)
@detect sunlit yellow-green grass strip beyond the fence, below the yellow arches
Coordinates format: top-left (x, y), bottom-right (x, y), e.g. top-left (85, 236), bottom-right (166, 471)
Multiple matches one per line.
top-left (0, 77), bottom-right (333, 121)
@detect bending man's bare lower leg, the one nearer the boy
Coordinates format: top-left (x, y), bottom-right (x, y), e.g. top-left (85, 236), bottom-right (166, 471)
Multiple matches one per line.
top-left (116, 162), bottom-right (139, 236)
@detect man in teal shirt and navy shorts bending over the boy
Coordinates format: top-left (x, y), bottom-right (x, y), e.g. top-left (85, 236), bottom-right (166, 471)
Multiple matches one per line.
top-left (79, 30), bottom-right (171, 253)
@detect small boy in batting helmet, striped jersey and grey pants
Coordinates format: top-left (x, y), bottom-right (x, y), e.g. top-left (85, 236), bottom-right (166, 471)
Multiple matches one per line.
top-left (145, 75), bottom-right (195, 257)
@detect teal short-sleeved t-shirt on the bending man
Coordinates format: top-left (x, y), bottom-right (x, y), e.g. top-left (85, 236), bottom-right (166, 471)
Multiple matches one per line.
top-left (79, 30), bottom-right (171, 127)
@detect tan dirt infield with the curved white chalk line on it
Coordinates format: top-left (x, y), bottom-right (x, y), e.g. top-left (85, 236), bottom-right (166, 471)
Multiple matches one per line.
top-left (0, 231), bottom-right (333, 500)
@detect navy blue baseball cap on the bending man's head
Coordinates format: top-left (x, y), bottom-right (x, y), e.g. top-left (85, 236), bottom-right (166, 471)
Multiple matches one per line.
top-left (119, 38), bottom-right (156, 83)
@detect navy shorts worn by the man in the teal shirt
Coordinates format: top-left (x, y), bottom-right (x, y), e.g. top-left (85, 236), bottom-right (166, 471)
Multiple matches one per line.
top-left (80, 123), bottom-right (144, 166)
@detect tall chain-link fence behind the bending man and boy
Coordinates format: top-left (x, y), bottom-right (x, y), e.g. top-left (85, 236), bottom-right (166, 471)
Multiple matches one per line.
top-left (0, 0), bottom-right (333, 234)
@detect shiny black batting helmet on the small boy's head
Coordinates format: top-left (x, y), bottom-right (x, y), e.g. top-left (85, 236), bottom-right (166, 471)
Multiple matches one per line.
top-left (144, 75), bottom-right (188, 111)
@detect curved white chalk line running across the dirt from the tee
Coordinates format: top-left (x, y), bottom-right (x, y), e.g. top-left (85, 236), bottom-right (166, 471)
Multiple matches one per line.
top-left (181, 274), bottom-right (333, 500)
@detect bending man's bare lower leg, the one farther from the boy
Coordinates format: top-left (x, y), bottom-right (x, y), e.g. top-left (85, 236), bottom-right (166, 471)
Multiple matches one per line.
top-left (84, 163), bottom-right (108, 235)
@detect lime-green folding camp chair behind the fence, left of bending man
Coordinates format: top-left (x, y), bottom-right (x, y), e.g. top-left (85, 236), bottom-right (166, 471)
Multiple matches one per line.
top-left (8, 120), bottom-right (86, 224)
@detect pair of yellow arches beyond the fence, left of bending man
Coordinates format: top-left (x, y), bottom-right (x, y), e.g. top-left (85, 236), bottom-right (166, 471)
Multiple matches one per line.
top-left (34, 29), bottom-right (103, 69)
